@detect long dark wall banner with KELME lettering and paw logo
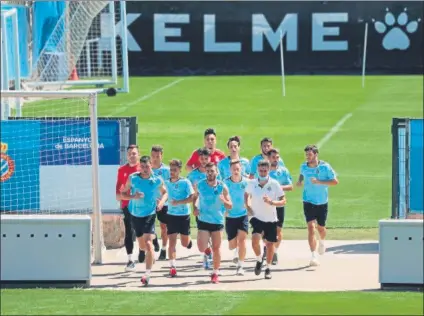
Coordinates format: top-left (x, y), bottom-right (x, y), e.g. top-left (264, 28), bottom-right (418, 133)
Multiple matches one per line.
top-left (118, 1), bottom-right (423, 75)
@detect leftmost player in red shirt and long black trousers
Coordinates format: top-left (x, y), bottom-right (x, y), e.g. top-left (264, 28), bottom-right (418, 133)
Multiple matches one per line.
top-left (116, 145), bottom-right (159, 271)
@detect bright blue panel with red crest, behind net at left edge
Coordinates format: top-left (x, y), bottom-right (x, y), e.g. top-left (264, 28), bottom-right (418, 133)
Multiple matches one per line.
top-left (0, 121), bottom-right (40, 212)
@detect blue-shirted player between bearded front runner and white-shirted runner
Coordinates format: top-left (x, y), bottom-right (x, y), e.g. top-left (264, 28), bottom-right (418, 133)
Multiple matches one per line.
top-left (224, 160), bottom-right (249, 275)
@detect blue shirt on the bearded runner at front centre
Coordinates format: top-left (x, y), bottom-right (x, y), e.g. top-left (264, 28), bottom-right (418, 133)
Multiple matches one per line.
top-left (197, 180), bottom-right (226, 225)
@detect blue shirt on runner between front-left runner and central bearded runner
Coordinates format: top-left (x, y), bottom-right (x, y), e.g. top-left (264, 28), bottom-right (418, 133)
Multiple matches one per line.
top-left (165, 178), bottom-right (194, 216)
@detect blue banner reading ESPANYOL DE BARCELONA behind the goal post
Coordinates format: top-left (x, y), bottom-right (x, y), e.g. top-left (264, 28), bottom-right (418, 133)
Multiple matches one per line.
top-left (41, 120), bottom-right (120, 166)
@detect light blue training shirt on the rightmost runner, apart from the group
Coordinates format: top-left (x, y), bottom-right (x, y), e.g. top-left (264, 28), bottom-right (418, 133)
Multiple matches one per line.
top-left (300, 160), bottom-right (336, 205)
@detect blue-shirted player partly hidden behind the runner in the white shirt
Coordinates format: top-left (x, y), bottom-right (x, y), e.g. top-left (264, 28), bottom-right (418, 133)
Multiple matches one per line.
top-left (267, 148), bottom-right (293, 265)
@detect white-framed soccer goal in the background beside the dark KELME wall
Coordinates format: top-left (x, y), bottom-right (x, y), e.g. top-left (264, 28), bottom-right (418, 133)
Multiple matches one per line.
top-left (12, 1), bottom-right (129, 92)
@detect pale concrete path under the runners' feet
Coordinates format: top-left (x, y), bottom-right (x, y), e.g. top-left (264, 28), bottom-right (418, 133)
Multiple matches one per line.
top-left (91, 240), bottom-right (380, 291)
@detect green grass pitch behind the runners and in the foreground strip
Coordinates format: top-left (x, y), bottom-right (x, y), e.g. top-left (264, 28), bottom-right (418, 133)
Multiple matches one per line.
top-left (1, 76), bottom-right (423, 315)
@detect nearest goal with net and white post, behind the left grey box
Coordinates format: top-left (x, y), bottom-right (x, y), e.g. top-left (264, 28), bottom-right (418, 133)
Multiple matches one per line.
top-left (0, 91), bottom-right (103, 263)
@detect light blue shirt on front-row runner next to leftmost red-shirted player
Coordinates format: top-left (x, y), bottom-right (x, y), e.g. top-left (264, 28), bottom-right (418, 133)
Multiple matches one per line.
top-left (128, 172), bottom-right (163, 217)
